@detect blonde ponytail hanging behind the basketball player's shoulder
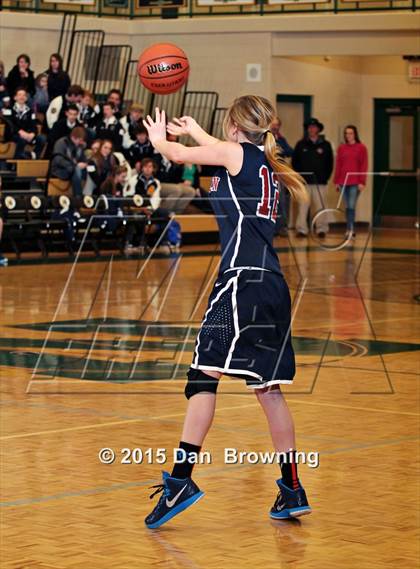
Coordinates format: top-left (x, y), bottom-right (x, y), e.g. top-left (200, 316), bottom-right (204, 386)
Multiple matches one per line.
top-left (264, 131), bottom-right (309, 202)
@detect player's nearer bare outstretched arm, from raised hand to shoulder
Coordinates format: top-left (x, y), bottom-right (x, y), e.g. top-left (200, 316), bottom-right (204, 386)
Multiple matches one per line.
top-left (143, 108), bottom-right (243, 175)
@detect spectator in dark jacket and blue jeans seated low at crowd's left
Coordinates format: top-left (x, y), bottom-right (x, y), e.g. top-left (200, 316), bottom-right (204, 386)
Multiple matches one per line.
top-left (50, 126), bottom-right (87, 196)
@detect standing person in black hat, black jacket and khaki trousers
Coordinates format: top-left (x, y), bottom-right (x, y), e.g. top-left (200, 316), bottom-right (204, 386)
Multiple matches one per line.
top-left (292, 118), bottom-right (334, 238)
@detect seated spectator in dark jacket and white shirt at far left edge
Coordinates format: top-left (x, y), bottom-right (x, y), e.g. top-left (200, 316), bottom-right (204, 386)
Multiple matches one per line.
top-left (2, 88), bottom-right (45, 159)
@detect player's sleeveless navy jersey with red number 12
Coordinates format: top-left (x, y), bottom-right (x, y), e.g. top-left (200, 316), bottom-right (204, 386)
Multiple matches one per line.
top-left (209, 142), bottom-right (281, 273)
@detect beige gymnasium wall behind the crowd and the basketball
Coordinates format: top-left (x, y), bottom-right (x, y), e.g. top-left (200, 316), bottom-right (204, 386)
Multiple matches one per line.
top-left (0, 12), bottom-right (420, 221)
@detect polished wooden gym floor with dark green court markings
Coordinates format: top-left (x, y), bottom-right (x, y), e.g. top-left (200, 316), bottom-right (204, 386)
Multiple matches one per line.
top-left (0, 230), bottom-right (420, 569)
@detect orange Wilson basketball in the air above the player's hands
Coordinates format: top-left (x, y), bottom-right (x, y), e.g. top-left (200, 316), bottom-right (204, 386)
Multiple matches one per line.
top-left (137, 43), bottom-right (190, 95)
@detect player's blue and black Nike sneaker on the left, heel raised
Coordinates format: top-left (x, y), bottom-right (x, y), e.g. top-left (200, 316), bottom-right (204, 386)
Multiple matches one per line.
top-left (144, 471), bottom-right (204, 529)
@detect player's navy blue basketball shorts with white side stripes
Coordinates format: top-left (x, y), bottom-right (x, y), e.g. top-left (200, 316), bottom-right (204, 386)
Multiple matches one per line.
top-left (191, 269), bottom-right (295, 388)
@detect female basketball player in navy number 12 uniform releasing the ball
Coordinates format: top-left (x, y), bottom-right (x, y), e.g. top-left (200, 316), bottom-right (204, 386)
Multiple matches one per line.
top-left (144, 96), bottom-right (311, 528)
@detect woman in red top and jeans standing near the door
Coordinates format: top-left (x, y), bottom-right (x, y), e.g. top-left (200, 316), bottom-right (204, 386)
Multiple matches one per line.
top-left (334, 125), bottom-right (368, 237)
